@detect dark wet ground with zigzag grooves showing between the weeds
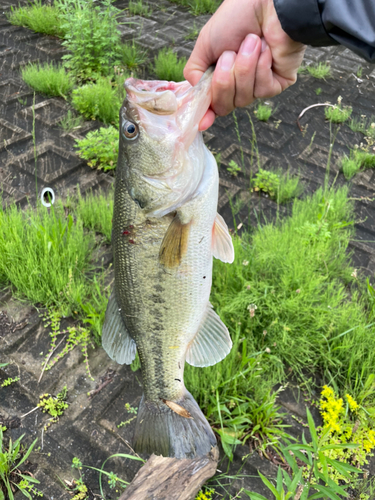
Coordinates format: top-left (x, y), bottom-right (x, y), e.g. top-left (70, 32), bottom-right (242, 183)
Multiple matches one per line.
top-left (0, 0), bottom-right (375, 500)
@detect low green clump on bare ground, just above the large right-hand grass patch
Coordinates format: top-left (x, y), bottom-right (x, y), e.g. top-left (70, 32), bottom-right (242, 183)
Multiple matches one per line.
top-left (253, 168), bottom-right (303, 203)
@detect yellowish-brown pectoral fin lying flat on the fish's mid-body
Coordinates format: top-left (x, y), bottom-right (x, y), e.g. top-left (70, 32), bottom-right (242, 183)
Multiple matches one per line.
top-left (159, 215), bottom-right (190, 267)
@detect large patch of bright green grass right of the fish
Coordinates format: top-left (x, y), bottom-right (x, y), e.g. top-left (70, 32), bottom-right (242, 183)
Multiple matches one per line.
top-left (185, 187), bottom-right (375, 428)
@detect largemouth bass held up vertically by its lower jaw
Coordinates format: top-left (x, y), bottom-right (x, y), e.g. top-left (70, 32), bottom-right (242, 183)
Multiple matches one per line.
top-left (102, 69), bottom-right (234, 459)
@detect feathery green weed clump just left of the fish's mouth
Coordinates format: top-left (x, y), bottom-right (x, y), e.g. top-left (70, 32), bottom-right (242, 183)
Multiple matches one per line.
top-left (72, 77), bottom-right (122, 126)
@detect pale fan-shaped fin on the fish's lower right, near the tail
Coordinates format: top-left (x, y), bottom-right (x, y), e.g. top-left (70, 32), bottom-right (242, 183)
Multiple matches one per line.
top-left (186, 303), bottom-right (232, 367)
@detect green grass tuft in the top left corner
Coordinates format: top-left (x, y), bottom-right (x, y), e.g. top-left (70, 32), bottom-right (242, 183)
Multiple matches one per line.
top-left (7, 0), bottom-right (65, 38)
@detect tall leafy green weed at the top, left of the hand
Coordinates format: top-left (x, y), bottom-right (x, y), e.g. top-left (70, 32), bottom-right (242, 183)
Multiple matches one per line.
top-left (60, 0), bottom-right (120, 80)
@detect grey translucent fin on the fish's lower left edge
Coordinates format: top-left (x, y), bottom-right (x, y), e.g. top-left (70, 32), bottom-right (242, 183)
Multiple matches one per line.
top-left (102, 292), bottom-right (137, 365)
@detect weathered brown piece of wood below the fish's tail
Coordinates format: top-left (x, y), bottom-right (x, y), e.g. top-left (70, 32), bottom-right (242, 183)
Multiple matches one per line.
top-left (119, 446), bottom-right (219, 500)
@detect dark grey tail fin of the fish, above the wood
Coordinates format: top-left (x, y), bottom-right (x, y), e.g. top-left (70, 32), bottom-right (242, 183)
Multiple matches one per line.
top-left (134, 390), bottom-right (216, 458)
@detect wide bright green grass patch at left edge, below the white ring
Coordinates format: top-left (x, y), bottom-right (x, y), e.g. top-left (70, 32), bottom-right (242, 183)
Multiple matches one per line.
top-left (0, 204), bottom-right (94, 316)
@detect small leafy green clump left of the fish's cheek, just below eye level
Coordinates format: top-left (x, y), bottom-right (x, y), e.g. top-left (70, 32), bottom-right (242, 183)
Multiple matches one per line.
top-left (76, 126), bottom-right (119, 172)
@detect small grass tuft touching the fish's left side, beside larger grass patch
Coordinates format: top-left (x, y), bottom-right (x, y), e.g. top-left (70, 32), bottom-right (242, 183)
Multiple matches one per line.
top-left (70, 189), bottom-right (113, 244)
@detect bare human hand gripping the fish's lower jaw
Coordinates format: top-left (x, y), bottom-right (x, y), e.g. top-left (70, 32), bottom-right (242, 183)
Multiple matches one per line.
top-left (184, 0), bottom-right (305, 130)
